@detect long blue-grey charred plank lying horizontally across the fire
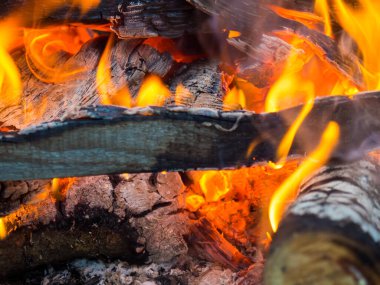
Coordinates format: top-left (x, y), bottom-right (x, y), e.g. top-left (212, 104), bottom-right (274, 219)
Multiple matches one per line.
top-left (0, 92), bottom-right (380, 180)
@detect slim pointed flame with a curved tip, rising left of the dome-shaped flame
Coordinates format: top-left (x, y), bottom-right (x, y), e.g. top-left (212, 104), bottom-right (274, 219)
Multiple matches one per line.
top-left (96, 36), bottom-right (132, 108)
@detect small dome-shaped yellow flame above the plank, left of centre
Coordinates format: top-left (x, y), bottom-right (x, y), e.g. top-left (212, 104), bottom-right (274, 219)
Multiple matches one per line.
top-left (136, 75), bottom-right (171, 107)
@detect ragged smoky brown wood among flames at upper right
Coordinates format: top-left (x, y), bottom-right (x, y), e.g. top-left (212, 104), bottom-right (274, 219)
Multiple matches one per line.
top-left (188, 0), bottom-right (362, 87)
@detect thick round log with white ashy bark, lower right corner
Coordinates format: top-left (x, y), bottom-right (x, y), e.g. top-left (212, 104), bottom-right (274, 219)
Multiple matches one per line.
top-left (265, 158), bottom-right (380, 285)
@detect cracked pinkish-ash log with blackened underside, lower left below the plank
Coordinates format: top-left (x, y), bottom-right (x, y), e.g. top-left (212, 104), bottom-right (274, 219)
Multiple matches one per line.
top-left (0, 173), bottom-right (188, 280)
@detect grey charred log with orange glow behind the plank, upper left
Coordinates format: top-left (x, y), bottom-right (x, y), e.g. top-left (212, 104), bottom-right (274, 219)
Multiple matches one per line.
top-left (0, 37), bottom-right (176, 129)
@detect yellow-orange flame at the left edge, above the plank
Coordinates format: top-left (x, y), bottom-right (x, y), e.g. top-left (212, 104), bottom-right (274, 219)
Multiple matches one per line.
top-left (0, 19), bottom-right (22, 106)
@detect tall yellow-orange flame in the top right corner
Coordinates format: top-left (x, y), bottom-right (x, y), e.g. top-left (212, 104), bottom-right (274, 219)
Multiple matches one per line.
top-left (333, 0), bottom-right (380, 90)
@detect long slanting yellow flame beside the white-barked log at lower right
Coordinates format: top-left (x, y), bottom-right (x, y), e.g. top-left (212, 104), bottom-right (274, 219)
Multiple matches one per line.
top-left (269, 122), bottom-right (340, 232)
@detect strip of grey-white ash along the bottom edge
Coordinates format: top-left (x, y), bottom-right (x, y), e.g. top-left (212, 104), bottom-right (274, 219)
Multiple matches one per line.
top-left (35, 259), bottom-right (238, 285)
